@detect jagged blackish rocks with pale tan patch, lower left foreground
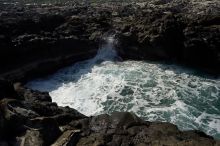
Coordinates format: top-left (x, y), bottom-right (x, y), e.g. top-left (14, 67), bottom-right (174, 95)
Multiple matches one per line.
top-left (0, 87), bottom-right (86, 145)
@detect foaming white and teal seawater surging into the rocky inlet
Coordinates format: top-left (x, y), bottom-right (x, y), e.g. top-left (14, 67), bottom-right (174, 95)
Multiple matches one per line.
top-left (27, 37), bottom-right (220, 139)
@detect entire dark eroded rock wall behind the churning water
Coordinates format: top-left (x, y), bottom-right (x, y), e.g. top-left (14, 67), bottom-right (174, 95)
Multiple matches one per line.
top-left (0, 0), bottom-right (220, 81)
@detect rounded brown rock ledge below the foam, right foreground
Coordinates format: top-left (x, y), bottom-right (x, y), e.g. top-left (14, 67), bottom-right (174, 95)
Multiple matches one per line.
top-left (67, 112), bottom-right (217, 146)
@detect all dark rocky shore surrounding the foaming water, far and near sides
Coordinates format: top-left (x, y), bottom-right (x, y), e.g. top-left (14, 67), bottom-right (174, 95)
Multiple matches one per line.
top-left (0, 0), bottom-right (220, 146)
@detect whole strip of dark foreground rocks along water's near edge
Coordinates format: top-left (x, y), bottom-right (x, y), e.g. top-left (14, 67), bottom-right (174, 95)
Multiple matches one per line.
top-left (0, 80), bottom-right (220, 146)
